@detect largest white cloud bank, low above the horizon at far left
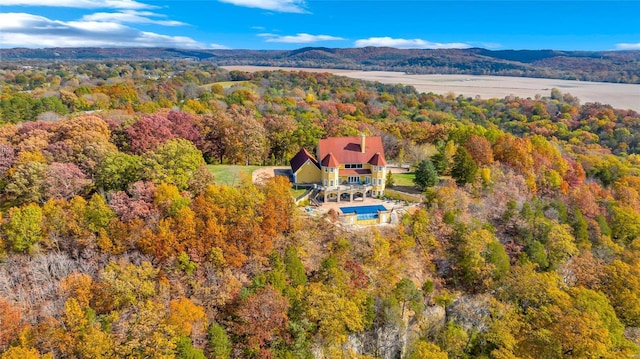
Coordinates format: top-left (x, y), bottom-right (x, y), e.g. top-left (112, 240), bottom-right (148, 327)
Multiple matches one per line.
top-left (0, 13), bottom-right (205, 48)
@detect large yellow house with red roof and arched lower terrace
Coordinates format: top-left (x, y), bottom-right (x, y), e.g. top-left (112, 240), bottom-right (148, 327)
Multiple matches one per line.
top-left (290, 134), bottom-right (387, 201)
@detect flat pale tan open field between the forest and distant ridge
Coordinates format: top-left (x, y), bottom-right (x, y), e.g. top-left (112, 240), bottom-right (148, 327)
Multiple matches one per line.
top-left (224, 66), bottom-right (640, 112)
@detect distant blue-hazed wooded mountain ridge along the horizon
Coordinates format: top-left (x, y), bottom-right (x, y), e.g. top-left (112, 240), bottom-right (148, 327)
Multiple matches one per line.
top-left (0, 47), bottom-right (640, 84)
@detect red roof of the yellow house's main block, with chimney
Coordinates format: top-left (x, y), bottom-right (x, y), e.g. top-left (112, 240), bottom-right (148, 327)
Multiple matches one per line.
top-left (318, 136), bottom-right (387, 167)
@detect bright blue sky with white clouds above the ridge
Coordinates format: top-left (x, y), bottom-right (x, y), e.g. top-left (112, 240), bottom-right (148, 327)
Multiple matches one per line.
top-left (0, 0), bottom-right (640, 51)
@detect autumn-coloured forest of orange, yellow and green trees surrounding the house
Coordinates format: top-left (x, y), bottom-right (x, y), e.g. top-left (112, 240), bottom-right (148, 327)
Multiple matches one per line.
top-left (0, 61), bottom-right (640, 358)
